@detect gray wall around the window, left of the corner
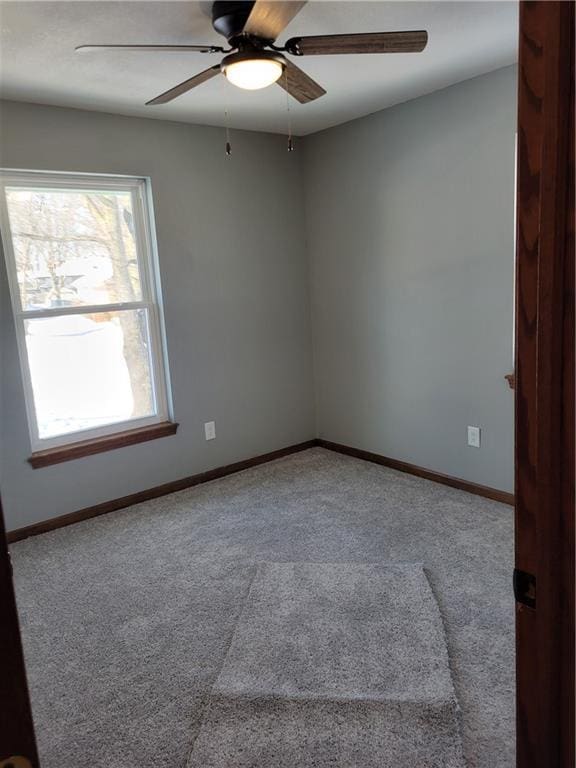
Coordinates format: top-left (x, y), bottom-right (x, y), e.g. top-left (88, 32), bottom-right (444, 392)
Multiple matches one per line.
top-left (0, 102), bottom-right (314, 528)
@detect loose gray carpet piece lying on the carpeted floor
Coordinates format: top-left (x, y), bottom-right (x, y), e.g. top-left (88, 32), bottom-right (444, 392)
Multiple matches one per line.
top-left (188, 563), bottom-right (464, 768)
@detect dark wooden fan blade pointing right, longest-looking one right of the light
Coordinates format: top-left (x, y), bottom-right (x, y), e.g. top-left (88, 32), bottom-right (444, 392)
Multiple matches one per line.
top-left (285, 30), bottom-right (428, 56)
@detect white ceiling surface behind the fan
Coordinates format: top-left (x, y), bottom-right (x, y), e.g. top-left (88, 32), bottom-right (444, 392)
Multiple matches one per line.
top-left (0, 0), bottom-right (518, 135)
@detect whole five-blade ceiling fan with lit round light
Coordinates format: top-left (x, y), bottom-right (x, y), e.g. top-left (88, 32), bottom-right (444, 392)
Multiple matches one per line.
top-left (76, 0), bottom-right (428, 105)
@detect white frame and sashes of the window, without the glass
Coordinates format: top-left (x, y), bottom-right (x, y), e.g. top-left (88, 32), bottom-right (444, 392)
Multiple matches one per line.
top-left (0, 169), bottom-right (172, 453)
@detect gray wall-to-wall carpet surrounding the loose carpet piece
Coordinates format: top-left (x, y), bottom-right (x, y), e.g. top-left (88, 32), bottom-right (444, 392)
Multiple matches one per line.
top-left (11, 448), bottom-right (514, 768)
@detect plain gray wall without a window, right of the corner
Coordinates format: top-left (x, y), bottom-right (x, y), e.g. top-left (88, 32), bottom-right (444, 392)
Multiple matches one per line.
top-left (305, 67), bottom-right (516, 491)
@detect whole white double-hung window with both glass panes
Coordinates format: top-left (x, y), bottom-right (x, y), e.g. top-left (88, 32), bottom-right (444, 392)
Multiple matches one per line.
top-left (0, 172), bottom-right (169, 462)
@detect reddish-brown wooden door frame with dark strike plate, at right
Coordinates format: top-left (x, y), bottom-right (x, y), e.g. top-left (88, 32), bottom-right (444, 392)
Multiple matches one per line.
top-left (515, 0), bottom-right (574, 768)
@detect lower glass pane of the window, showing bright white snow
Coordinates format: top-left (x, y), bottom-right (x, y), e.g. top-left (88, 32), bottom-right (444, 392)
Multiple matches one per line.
top-left (25, 309), bottom-right (156, 439)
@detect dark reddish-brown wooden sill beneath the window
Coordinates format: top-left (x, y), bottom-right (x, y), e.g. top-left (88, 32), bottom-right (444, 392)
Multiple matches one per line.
top-left (28, 421), bottom-right (178, 469)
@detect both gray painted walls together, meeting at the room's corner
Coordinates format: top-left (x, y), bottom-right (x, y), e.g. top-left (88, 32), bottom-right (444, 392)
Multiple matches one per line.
top-left (0, 68), bottom-right (516, 528)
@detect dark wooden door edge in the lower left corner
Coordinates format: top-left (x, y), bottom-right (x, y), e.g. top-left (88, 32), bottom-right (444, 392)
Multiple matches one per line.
top-left (0, 502), bottom-right (39, 768)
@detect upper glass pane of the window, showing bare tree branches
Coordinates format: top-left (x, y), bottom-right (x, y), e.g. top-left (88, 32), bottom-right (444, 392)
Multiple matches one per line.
top-left (6, 187), bottom-right (142, 310)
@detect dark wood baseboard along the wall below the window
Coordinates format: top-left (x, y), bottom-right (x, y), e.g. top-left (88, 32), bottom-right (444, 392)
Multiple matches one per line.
top-left (7, 440), bottom-right (316, 543)
